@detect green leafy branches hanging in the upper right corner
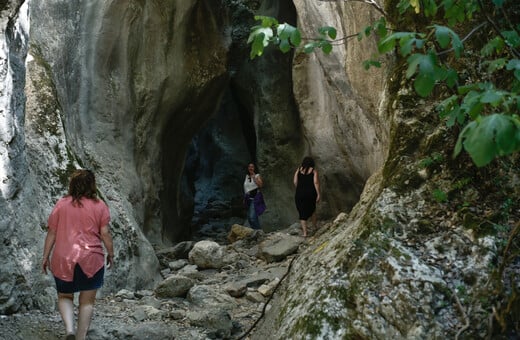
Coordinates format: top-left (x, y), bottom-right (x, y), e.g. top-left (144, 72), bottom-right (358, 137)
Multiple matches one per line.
top-left (248, 0), bottom-right (520, 167)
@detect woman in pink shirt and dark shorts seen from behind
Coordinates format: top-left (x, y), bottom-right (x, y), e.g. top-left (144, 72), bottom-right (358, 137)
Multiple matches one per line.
top-left (42, 169), bottom-right (114, 340)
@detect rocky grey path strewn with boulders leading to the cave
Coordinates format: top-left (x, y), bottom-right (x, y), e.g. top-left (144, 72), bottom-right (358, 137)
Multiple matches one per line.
top-left (0, 224), bottom-right (312, 340)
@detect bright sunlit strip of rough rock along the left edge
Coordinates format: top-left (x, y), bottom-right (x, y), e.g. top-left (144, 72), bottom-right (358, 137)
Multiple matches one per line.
top-left (0, 1), bottom-right (34, 314)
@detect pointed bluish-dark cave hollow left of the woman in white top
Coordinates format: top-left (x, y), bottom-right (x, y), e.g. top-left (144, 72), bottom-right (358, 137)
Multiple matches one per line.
top-left (181, 86), bottom-right (256, 240)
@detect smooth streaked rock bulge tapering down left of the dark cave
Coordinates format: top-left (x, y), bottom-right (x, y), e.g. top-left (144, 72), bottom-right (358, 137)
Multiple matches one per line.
top-left (31, 1), bottom-right (232, 241)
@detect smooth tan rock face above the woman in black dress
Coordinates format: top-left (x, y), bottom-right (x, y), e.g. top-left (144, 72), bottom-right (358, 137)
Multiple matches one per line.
top-left (293, 1), bottom-right (388, 214)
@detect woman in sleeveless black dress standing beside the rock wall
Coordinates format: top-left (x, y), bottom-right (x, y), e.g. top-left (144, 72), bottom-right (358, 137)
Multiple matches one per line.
top-left (293, 157), bottom-right (320, 237)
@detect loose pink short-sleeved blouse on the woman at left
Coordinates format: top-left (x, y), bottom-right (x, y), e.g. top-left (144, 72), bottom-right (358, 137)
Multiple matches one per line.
top-left (47, 196), bottom-right (110, 282)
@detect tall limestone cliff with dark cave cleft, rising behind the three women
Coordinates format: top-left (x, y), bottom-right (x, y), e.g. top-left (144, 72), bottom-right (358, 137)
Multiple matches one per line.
top-left (2, 0), bottom-right (394, 316)
